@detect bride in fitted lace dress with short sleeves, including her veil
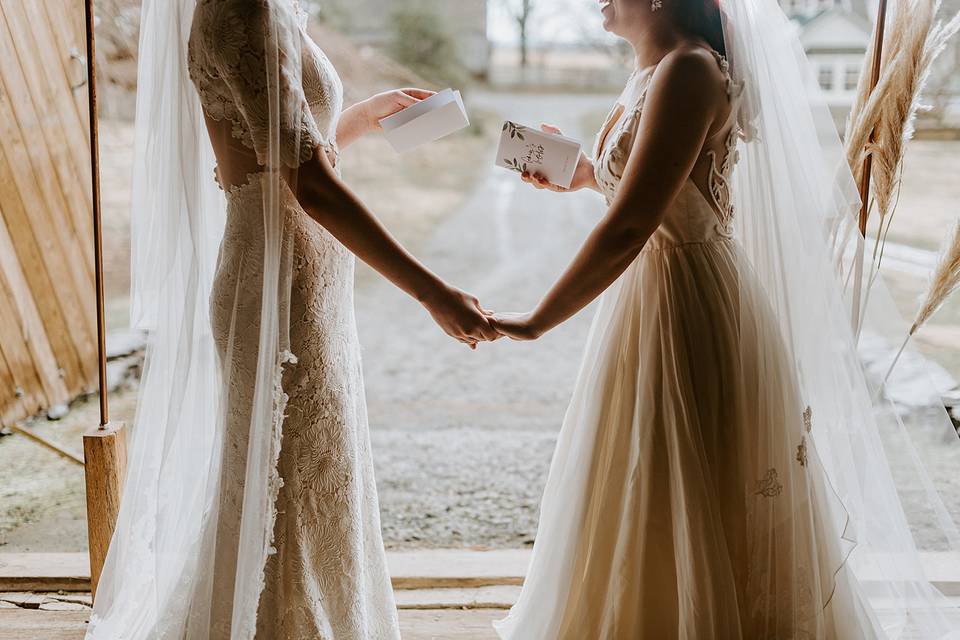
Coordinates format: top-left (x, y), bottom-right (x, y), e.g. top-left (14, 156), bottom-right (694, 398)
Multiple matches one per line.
top-left (88, 0), bottom-right (497, 640)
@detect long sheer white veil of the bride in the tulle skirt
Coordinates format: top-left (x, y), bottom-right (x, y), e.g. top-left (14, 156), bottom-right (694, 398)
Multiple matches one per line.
top-left (721, 0), bottom-right (960, 638)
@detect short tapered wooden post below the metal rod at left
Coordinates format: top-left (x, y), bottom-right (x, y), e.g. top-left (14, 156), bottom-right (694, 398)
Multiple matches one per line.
top-left (83, 424), bottom-right (127, 597)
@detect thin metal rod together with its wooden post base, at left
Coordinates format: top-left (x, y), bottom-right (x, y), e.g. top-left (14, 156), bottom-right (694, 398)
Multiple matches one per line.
top-left (83, 0), bottom-right (127, 594)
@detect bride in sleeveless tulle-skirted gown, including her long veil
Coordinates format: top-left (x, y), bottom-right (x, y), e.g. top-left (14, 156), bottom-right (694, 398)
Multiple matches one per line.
top-left (494, 0), bottom-right (952, 640)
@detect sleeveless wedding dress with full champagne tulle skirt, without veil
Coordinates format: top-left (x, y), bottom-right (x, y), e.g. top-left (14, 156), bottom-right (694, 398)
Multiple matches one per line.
top-left (495, 54), bottom-right (874, 640)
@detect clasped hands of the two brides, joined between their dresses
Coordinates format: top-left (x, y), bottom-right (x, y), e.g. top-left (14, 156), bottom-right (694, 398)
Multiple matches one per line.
top-left (422, 286), bottom-right (544, 349)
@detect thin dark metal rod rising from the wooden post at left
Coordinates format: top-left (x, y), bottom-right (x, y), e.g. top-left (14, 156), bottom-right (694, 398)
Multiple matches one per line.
top-left (84, 0), bottom-right (110, 429)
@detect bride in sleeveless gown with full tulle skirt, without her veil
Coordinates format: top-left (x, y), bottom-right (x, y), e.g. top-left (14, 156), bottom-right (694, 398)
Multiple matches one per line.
top-left (494, 0), bottom-right (956, 640)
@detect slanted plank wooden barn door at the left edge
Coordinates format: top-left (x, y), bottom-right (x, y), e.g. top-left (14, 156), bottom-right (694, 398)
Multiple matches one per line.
top-left (0, 0), bottom-right (97, 426)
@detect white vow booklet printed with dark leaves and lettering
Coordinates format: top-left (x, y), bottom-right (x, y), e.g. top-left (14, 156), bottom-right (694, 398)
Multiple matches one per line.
top-left (497, 121), bottom-right (580, 189)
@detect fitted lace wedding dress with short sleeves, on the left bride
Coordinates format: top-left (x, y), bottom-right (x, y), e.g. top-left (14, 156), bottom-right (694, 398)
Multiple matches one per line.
top-left (189, 0), bottom-right (400, 640)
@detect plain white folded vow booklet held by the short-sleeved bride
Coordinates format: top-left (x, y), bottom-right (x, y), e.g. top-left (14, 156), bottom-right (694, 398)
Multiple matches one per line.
top-left (380, 89), bottom-right (470, 153)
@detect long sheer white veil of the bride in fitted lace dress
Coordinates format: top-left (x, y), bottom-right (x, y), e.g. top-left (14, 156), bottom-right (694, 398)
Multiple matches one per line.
top-left (87, 0), bottom-right (305, 640)
